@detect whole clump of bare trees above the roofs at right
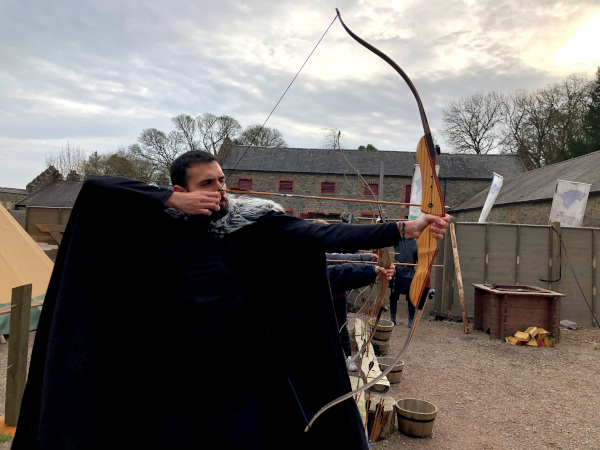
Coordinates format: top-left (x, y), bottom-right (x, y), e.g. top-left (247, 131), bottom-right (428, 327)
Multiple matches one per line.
top-left (442, 75), bottom-right (593, 167)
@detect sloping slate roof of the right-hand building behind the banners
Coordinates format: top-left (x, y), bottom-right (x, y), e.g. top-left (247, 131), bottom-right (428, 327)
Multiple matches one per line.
top-left (453, 151), bottom-right (600, 212)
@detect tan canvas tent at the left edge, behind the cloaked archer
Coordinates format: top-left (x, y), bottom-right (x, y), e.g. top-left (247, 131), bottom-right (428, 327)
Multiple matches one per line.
top-left (0, 205), bottom-right (54, 334)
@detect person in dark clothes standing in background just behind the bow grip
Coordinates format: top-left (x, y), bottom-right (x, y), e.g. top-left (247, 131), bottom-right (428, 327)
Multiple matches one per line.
top-left (390, 239), bottom-right (418, 327)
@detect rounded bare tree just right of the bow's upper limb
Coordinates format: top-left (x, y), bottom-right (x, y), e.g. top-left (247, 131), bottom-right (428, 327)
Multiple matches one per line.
top-left (442, 91), bottom-right (504, 154)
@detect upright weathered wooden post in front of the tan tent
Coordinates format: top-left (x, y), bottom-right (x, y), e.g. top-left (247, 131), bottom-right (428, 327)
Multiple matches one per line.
top-left (4, 284), bottom-right (31, 427)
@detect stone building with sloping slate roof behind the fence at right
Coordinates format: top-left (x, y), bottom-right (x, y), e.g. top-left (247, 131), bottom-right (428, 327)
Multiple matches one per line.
top-left (453, 151), bottom-right (600, 227)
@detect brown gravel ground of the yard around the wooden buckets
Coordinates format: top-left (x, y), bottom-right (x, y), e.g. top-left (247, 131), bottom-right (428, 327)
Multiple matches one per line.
top-left (0, 315), bottom-right (600, 450)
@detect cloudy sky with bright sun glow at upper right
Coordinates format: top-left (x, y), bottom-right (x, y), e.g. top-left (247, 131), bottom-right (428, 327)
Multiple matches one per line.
top-left (0, 0), bottom-right (600, 188)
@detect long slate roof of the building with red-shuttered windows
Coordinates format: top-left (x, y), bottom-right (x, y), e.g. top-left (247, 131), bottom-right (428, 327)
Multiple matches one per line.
top-left (221, 145), bottom-right (525, 180)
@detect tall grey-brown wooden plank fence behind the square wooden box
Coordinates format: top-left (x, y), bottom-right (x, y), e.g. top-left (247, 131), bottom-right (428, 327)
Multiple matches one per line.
top-left (436, 222), bottom-right (600, 326)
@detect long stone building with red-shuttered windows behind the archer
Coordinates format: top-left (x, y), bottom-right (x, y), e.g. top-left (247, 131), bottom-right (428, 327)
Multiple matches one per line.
top-left (218, 143), bottom-right (525, 220)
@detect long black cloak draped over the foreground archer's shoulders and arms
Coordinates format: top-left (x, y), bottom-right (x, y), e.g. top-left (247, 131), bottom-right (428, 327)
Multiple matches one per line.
top-left (13, 177), bottom-right (399, 450)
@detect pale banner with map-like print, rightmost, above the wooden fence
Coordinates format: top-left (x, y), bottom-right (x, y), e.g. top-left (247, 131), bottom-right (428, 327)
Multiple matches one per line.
top-left (548, 180), bottom-right (592, 227)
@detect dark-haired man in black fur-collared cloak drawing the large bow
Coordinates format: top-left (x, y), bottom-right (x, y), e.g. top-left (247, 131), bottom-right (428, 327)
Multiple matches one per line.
top-left (13, 151), bottom-right (449, 450)
